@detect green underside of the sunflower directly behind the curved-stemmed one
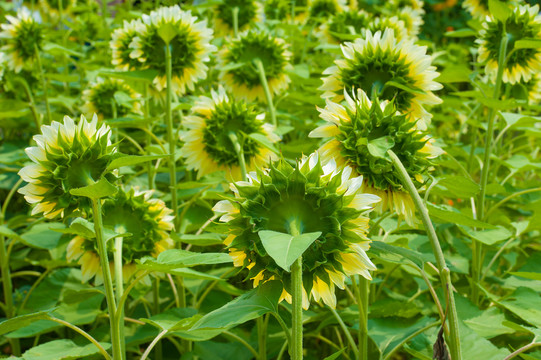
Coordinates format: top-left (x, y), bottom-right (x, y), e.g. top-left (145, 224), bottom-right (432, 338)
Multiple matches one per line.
top-left (338, 49), bottom-right (414, 112)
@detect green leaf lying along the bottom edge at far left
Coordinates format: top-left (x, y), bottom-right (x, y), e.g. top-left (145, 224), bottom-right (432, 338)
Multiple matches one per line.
top-left (19, 339), bottom-right (110, 360)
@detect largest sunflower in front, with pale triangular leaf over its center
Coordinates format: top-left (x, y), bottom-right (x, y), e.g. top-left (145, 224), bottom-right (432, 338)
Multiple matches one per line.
top-left (214, 152), bottom-right (379, 309)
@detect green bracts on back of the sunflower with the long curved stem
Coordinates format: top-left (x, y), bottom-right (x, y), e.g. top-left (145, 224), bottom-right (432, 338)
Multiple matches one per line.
top-left (336, 102), bottom-right (430, 190)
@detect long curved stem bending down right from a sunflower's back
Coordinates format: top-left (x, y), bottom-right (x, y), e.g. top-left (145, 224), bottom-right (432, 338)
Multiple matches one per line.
top-left (387, 150), bottom-right (462, 360)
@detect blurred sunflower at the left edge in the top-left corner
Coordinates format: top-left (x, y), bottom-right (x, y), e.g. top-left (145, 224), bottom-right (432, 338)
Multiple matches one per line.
top-left (0, 7), bottom-right (43, 73)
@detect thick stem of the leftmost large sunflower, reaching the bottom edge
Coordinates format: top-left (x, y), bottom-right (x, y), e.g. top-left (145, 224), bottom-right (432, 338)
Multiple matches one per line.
top-left (92, 199), bottom-right (124, 360)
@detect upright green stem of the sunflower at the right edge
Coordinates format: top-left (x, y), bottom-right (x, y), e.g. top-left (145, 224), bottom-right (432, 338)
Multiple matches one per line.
top-left (472, 33), bottom-right (508, 305)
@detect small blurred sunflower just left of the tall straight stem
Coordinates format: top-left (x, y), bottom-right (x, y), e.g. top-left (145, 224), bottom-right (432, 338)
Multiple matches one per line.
top-left (82, 78), bottom-right (142, 120)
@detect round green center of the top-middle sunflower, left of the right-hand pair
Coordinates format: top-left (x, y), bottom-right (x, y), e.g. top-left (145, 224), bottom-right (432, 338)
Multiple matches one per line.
top-left (226, 33), bottom-right (287, 88)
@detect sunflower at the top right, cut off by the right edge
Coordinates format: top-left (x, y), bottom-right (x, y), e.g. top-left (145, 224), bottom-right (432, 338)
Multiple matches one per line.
top-left (476, 5), bottom-right (541, 84)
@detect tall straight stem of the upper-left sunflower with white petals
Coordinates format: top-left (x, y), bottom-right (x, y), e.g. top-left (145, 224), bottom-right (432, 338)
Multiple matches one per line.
top-left (165, 44), bottom-right (180, 231)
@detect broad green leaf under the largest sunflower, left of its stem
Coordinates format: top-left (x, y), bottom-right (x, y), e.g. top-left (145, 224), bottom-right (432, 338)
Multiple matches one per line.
top-left (190, 281), bottom-right (283, 331)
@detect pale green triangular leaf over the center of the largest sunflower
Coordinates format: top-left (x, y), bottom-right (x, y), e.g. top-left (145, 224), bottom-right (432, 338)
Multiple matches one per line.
top-left (258, 230), bottom-right (321, 271)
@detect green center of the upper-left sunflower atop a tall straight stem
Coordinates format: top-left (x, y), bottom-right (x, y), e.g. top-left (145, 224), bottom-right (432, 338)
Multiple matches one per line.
top-left (142, 26), bottom-right (199, 75)
